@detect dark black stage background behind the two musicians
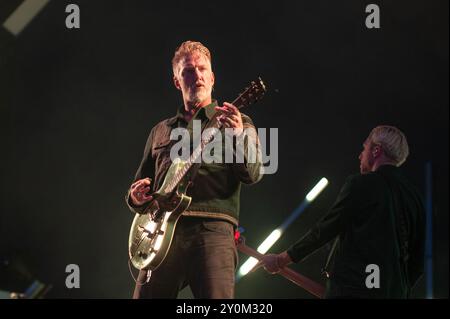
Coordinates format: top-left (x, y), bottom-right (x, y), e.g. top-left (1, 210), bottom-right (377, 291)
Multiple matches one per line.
top-left (0, 0), bottom-right (449, 298)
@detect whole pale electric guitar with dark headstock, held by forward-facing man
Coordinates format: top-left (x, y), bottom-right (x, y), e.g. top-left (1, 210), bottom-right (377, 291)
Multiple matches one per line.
top-left (128, 78), bottom-right (266, 271)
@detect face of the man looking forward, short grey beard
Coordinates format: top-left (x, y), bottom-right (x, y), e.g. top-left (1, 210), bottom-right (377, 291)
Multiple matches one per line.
top-left (174, 52), bottom-right (214, 104)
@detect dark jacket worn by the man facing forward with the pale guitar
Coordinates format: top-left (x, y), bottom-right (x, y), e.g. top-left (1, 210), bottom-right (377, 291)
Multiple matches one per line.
top-left (125, 101), bottom-right (262, 225)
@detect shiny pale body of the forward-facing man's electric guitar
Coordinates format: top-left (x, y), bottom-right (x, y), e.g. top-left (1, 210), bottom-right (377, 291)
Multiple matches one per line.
top-left (128, 160), bottom-right (191, 271)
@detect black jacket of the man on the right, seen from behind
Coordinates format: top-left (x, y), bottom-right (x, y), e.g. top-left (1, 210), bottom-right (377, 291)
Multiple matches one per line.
top-left (288, 165), bottom-right (425, 298)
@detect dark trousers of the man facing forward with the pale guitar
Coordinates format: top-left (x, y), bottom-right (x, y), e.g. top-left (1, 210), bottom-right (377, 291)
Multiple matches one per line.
top-left (133, 216), bottom-right (238, 299)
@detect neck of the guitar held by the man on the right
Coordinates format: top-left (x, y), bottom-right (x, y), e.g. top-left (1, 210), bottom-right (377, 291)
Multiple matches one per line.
top-left (237, 243), bottom-right (325, 298)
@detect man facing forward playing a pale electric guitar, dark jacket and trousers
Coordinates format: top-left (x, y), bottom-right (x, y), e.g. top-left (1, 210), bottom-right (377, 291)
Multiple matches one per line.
top-left (125, 41), bottom-right (262, 298)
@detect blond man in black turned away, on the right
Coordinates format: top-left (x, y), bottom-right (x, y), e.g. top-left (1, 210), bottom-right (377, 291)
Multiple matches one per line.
top-left (255, 125), bottom-right (425, 298)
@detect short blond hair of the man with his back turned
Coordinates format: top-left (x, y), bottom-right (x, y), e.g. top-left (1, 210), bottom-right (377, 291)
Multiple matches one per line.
top-left (368, 125), bottom-right (409, 166)
